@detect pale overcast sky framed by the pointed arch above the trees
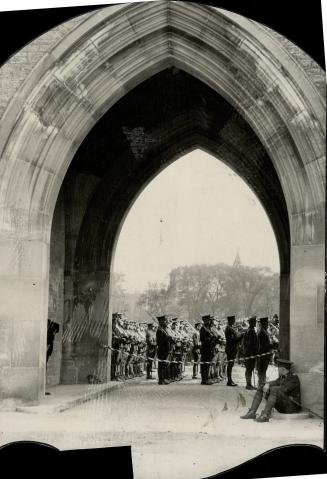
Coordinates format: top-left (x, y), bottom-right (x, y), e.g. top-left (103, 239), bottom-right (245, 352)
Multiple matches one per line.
top-left (114, 150), bottom-right (279, 292)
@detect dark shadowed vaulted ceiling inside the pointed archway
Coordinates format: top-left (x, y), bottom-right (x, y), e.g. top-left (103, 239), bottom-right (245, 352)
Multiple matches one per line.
top-left (68, 68), bottom-right (289, 276)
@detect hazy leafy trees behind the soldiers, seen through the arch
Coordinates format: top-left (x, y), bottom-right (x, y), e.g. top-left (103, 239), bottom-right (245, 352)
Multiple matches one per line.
top-left (138, 263), bottom-right (279, 324)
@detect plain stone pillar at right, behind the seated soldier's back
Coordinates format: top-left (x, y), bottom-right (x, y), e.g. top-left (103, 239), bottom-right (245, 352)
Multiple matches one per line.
top-left (290, 244), bottom-right (325, 415)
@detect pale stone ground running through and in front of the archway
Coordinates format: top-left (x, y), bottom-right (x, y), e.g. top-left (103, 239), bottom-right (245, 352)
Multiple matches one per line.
top-left (0, 366), bottom-right (323, 479)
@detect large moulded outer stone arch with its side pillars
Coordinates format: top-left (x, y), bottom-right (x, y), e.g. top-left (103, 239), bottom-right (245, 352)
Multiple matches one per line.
top-left (0, 1), bottom-right (325, 414)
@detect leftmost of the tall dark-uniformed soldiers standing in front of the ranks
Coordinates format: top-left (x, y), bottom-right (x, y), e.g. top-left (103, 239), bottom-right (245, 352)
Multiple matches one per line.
top-left (156, 315), bottom-right (172, 384)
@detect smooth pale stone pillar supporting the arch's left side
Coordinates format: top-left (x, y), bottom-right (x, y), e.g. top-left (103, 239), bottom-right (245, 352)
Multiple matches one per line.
top-left (0, 232), bottom-right (49, 404)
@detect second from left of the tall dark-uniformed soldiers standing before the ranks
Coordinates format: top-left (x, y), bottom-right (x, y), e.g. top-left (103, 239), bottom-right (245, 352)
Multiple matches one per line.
top-left (200, 314), bottom-right (216, 386)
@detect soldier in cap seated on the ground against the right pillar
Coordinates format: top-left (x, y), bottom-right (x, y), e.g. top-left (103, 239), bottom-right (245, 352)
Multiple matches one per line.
top-left (241, 359), bottom-right (301, 422)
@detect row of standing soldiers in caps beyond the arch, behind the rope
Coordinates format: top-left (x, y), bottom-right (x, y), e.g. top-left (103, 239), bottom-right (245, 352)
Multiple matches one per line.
top-left (111, 313), bottom-right (278, 389)
